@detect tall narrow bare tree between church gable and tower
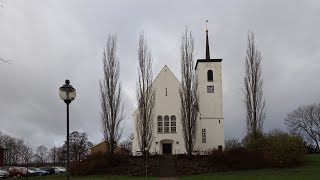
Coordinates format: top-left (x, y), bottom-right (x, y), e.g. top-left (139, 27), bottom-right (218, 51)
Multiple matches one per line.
top-left (179, 28), bottom-right (199, 155)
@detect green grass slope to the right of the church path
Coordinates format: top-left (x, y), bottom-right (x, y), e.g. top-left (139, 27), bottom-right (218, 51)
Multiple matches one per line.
top-left (180, 155), bottom-right (320, 180)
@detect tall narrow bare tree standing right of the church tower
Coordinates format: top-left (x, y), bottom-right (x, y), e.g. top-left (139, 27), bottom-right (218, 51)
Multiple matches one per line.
top-left (244, 32), bottom-right (266, 138)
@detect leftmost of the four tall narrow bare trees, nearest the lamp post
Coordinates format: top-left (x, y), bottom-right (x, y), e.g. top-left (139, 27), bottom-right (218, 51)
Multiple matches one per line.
top-left (100, 35), bottom-right (124, 154)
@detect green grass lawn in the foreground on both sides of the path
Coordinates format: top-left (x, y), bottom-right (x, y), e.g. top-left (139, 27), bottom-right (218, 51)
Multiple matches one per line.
top-left (21, 155), bottom-right (320, 180)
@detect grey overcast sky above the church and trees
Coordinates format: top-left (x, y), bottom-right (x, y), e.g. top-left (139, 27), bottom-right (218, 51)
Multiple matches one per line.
top-left (0, 0), bottom-right (320, 147)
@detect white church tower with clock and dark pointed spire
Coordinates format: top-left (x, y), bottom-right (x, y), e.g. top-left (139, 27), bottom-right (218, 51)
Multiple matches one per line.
top-left (195, 29), bottom-right (224, 150)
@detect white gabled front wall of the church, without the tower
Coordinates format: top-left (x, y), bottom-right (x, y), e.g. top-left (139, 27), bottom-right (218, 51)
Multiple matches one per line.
top-left (133, 66), bottom-right (185, 155)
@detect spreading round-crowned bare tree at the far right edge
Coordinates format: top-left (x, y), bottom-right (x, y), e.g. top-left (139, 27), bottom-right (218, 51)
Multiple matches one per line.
top-left (284, 103), bottom-right (320, 149)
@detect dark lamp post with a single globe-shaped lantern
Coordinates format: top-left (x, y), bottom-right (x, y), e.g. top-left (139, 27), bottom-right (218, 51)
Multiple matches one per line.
top-left (59, 79), bottom-right (76, 180)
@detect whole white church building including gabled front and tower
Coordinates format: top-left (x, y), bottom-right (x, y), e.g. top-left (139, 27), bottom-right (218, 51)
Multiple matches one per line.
top-left (132, 30), bottom-right (224, 155)
